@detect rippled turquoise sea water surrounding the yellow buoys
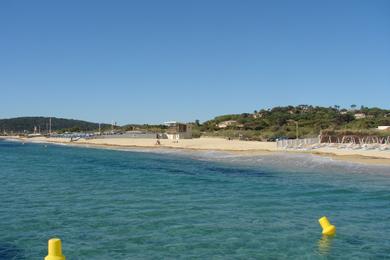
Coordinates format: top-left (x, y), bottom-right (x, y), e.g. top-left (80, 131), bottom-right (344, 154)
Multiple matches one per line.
top-left (0, 141), bottom-right (390, 259)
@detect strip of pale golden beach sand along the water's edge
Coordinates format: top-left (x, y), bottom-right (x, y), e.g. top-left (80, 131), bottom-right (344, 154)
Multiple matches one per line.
top-left (0, 136), bottom-right (390, 165)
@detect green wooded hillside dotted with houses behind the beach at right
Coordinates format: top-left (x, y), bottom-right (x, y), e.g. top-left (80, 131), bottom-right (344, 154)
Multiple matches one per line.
top-left (194, 105), bottom-right (390, 141)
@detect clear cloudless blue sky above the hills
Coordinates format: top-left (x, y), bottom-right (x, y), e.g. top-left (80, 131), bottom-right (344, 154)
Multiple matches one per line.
top-left (0, 0), bottom-right (390, 124)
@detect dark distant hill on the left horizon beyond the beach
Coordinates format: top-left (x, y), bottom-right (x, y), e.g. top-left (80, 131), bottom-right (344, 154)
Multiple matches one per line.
top-left (0, 116), bottom-right (109, 133)
